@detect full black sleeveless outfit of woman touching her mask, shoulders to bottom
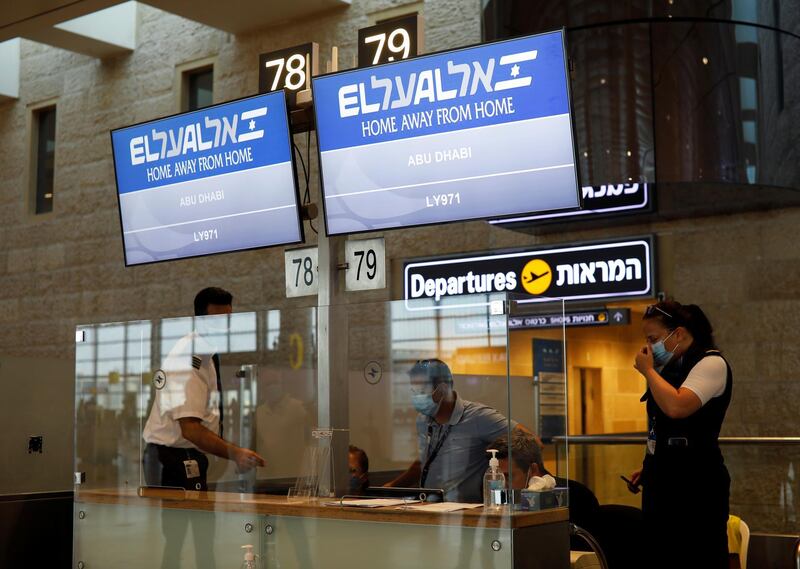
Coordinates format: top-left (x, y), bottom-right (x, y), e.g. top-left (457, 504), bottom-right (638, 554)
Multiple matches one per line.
top-left (642, 347), bottom-right (733, 569)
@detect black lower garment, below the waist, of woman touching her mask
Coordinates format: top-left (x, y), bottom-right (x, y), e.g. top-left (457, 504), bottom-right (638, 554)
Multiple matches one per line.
top-left (642, 447), bottom-right (730, 569)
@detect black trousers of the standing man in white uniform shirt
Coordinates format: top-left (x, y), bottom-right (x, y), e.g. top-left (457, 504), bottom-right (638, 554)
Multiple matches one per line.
top-left (142, 443), bottom-right (216, 569)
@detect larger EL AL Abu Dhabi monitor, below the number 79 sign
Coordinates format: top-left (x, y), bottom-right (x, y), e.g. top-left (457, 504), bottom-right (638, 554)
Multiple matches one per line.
top-left (313, 31), bottom-right (580, 235)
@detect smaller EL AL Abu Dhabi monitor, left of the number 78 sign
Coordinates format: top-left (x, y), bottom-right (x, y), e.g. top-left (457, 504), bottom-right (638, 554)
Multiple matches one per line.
top-left (111, 91), bottom-right (303, 266)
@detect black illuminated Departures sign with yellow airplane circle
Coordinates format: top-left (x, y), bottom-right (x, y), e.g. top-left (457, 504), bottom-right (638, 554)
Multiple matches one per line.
top-left (405, 237), bottom-right (654, 310)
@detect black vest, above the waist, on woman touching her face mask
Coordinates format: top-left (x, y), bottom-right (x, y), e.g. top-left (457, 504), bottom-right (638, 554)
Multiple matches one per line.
top-left (642, 348), bottom-right (733, 460)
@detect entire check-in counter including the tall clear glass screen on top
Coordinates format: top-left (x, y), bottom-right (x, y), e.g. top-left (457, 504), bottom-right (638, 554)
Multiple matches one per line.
top-left (73, 296), bottom-right (569, 569)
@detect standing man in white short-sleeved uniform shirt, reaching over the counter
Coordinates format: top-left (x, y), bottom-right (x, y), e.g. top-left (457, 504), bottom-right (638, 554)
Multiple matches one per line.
top-left (143, 287), bottom-right (265, 490)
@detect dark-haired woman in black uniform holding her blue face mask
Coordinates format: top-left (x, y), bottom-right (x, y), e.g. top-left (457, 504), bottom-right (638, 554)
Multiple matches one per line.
top-left (632, 300), bottom-right (733, 569)
